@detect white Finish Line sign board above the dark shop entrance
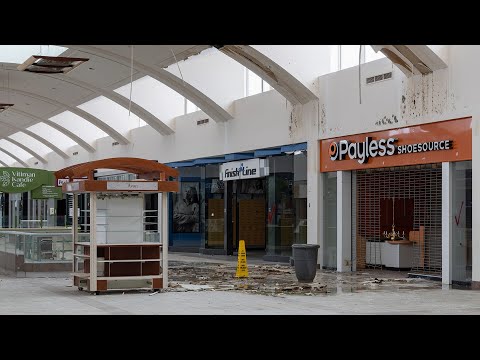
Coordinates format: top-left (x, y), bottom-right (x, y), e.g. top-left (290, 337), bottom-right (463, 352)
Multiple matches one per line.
top-left (220, 159), bottom-right (269, 181)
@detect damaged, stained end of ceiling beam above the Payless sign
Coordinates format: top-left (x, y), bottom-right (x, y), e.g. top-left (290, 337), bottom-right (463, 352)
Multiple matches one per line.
top-left (370, 45), bottom-right (447, 77)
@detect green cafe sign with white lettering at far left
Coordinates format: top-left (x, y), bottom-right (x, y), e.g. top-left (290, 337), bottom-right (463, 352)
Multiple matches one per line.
top-left (0, 167), bottom-right (55, 193)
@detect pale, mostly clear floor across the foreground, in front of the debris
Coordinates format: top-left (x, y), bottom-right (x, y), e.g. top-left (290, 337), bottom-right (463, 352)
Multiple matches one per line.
top-left (0, 258), bottom-right (480, 315)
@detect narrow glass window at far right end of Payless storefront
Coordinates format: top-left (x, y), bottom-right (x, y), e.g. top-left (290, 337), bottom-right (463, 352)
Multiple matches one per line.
top-left (451, 161), bottom-right (472, 282)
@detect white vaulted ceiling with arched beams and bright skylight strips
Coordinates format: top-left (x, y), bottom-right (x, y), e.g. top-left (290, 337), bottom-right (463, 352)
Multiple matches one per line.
top-left (0, 45), bottom-right (438, 165)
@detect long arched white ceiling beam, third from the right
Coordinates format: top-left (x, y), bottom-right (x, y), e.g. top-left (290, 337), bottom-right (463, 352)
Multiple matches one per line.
top-left (61, 45), bottom-right (233, 122)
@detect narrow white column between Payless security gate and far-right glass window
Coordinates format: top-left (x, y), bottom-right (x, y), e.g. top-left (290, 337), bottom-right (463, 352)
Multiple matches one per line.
top-left (442, 162), bottom-right (453, 285)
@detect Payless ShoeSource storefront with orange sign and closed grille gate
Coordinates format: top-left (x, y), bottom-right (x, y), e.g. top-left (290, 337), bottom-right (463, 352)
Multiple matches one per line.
top-left (320, 118), bottom-right (472, 284)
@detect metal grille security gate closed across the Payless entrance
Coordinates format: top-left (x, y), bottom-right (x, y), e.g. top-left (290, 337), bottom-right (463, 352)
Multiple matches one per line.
top-left (352, 164), bottom-right (442, 276)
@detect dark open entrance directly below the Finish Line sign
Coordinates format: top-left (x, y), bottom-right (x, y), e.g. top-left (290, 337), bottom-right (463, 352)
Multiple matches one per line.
top-left (228, 178), bottom-right (266, 250)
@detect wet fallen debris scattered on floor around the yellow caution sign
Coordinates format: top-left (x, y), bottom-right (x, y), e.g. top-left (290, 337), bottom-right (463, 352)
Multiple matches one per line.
top-left (166, 261), bottom-right (439, 296)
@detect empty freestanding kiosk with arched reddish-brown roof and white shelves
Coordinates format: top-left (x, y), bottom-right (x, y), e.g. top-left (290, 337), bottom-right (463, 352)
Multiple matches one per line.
top-left (55, 158), bottom-right (179, 294)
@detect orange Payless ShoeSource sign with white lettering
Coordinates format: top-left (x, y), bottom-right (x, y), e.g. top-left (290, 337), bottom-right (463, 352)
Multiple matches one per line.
top-left (320, 118), bottom-right (472, 172)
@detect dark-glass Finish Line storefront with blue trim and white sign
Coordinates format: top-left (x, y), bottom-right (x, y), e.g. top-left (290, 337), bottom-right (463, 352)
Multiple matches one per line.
top-left (167, 143), bottom-right (307, 261)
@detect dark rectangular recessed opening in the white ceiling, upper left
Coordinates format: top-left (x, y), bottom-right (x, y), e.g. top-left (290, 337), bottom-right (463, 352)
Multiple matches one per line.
top-left (17, 55), bottom-right (89, 74)
